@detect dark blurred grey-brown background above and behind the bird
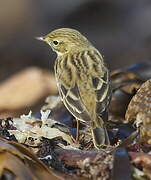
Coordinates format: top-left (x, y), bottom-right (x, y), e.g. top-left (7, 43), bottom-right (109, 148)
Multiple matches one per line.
top-left (0, 0), bottom-right (151, 116)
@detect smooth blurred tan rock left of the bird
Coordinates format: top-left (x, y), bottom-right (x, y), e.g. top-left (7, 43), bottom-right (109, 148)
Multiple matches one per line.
top-left (0, 67), bottom-right (57, 116)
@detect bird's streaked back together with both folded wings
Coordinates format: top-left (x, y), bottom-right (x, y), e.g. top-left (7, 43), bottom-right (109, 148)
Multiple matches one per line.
top-left (55, 49), bottom-right (110, 122)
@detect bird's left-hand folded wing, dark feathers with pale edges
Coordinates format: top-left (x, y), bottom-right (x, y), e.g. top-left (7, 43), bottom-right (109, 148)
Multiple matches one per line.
top-left (55, 57), bottom-right (91, 125)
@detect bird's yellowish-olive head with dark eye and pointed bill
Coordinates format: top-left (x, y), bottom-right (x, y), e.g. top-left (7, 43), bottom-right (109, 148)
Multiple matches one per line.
top-left (36, 28), bottom-right (91, 55)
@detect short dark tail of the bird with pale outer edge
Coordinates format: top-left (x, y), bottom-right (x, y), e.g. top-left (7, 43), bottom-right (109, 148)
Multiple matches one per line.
top-left (92, 118), bottom-right (110, 149)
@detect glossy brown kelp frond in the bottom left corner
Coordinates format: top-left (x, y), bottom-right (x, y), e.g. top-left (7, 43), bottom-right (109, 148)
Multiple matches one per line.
top-left (0, 139), bottom-right (60, 180)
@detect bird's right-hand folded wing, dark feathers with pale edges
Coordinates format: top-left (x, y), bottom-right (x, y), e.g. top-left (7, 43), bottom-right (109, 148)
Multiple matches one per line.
top-left (81, 48), bottom-right (111, 114)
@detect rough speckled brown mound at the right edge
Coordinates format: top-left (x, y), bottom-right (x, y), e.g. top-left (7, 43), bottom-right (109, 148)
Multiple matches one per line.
top-left (125, 79), bottom-right (151, 144)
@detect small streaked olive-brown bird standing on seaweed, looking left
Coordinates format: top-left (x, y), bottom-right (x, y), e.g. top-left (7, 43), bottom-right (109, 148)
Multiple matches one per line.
top-left (36, 28), bottom-right (112, 149)
